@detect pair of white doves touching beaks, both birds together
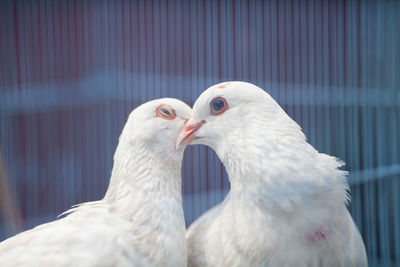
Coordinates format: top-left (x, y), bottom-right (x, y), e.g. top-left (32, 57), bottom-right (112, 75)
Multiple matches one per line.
top-left (0, 82), bottom-right (367, 267)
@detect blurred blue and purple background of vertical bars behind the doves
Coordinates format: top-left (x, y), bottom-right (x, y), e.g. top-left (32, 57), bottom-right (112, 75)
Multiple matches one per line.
top-left (0, 0), bottom-right (400, 266)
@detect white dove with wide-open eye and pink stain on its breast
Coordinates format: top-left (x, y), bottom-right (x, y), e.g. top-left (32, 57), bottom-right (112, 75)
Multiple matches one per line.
top-left (177, 82), bottom-right (367, 267)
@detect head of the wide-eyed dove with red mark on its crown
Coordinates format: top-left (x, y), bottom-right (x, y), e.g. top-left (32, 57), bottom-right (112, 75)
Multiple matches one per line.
top-left (177, 81), bottom-right (304, 153)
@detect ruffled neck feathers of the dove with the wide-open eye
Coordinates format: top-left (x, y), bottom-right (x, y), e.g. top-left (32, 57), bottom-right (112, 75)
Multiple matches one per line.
top-left (215, 113), bottom-right (348, 213)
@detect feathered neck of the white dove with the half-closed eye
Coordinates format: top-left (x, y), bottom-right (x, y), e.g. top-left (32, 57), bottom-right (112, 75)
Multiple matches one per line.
top-left (104, 136), bottom-right (183, 219)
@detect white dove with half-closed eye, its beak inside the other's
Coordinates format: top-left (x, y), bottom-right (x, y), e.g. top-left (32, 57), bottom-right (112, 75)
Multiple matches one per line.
top-left (0, 98), bottom-right (191, 267)
